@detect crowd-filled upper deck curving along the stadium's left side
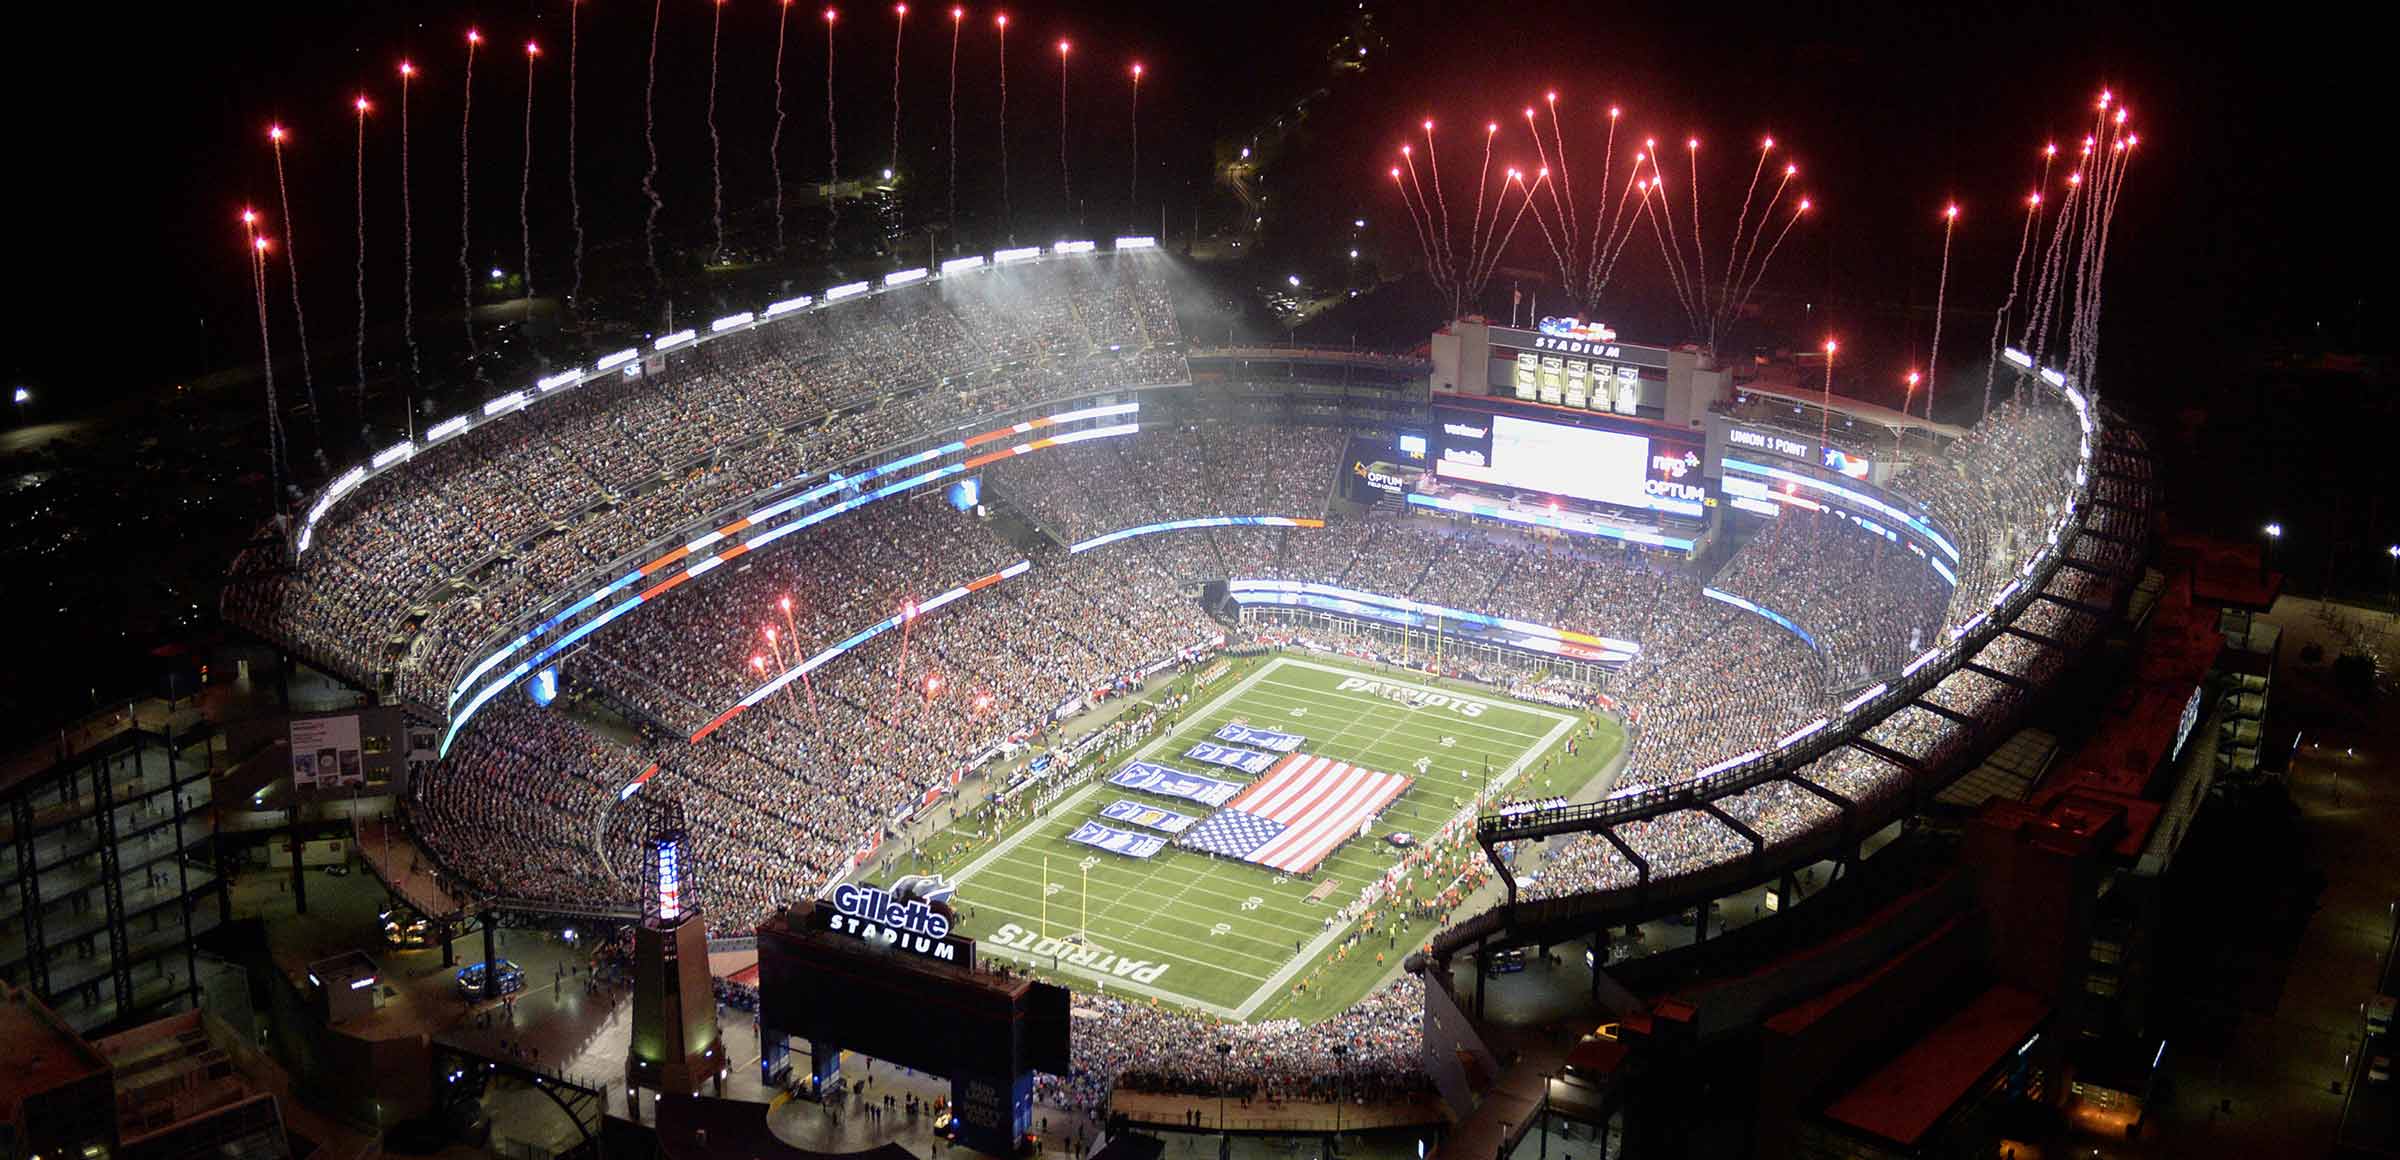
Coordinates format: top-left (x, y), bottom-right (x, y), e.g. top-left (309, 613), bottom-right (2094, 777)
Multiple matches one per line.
top-left (226, 255), bottom-right (1188, 708)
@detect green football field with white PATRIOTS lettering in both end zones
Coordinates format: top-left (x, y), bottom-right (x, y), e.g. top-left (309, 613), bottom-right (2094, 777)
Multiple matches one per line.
top-left (953, 656), bottom-right (1625, 1018)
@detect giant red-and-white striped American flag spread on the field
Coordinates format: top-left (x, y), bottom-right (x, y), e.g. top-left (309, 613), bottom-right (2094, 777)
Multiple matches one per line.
top-left (1181, 754), bottom-right (1409, 874)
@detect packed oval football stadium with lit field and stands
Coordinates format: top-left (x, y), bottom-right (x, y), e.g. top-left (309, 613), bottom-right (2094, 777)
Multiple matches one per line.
top-left (223, 222), bottom-right (2150, 1128)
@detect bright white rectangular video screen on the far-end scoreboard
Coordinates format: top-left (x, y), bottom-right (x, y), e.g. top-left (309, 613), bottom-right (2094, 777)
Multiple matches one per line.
top-left (1435, 411), bottom-right (1651, 509)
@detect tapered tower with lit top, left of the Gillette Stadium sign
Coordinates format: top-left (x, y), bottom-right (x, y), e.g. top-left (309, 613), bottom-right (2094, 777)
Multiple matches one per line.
top-left (624, 797), bottom-right (725, 1124)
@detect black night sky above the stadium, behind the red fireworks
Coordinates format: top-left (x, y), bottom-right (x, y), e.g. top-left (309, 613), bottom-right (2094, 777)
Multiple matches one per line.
top-left (10, 0), bottom-right (2388, 403)
